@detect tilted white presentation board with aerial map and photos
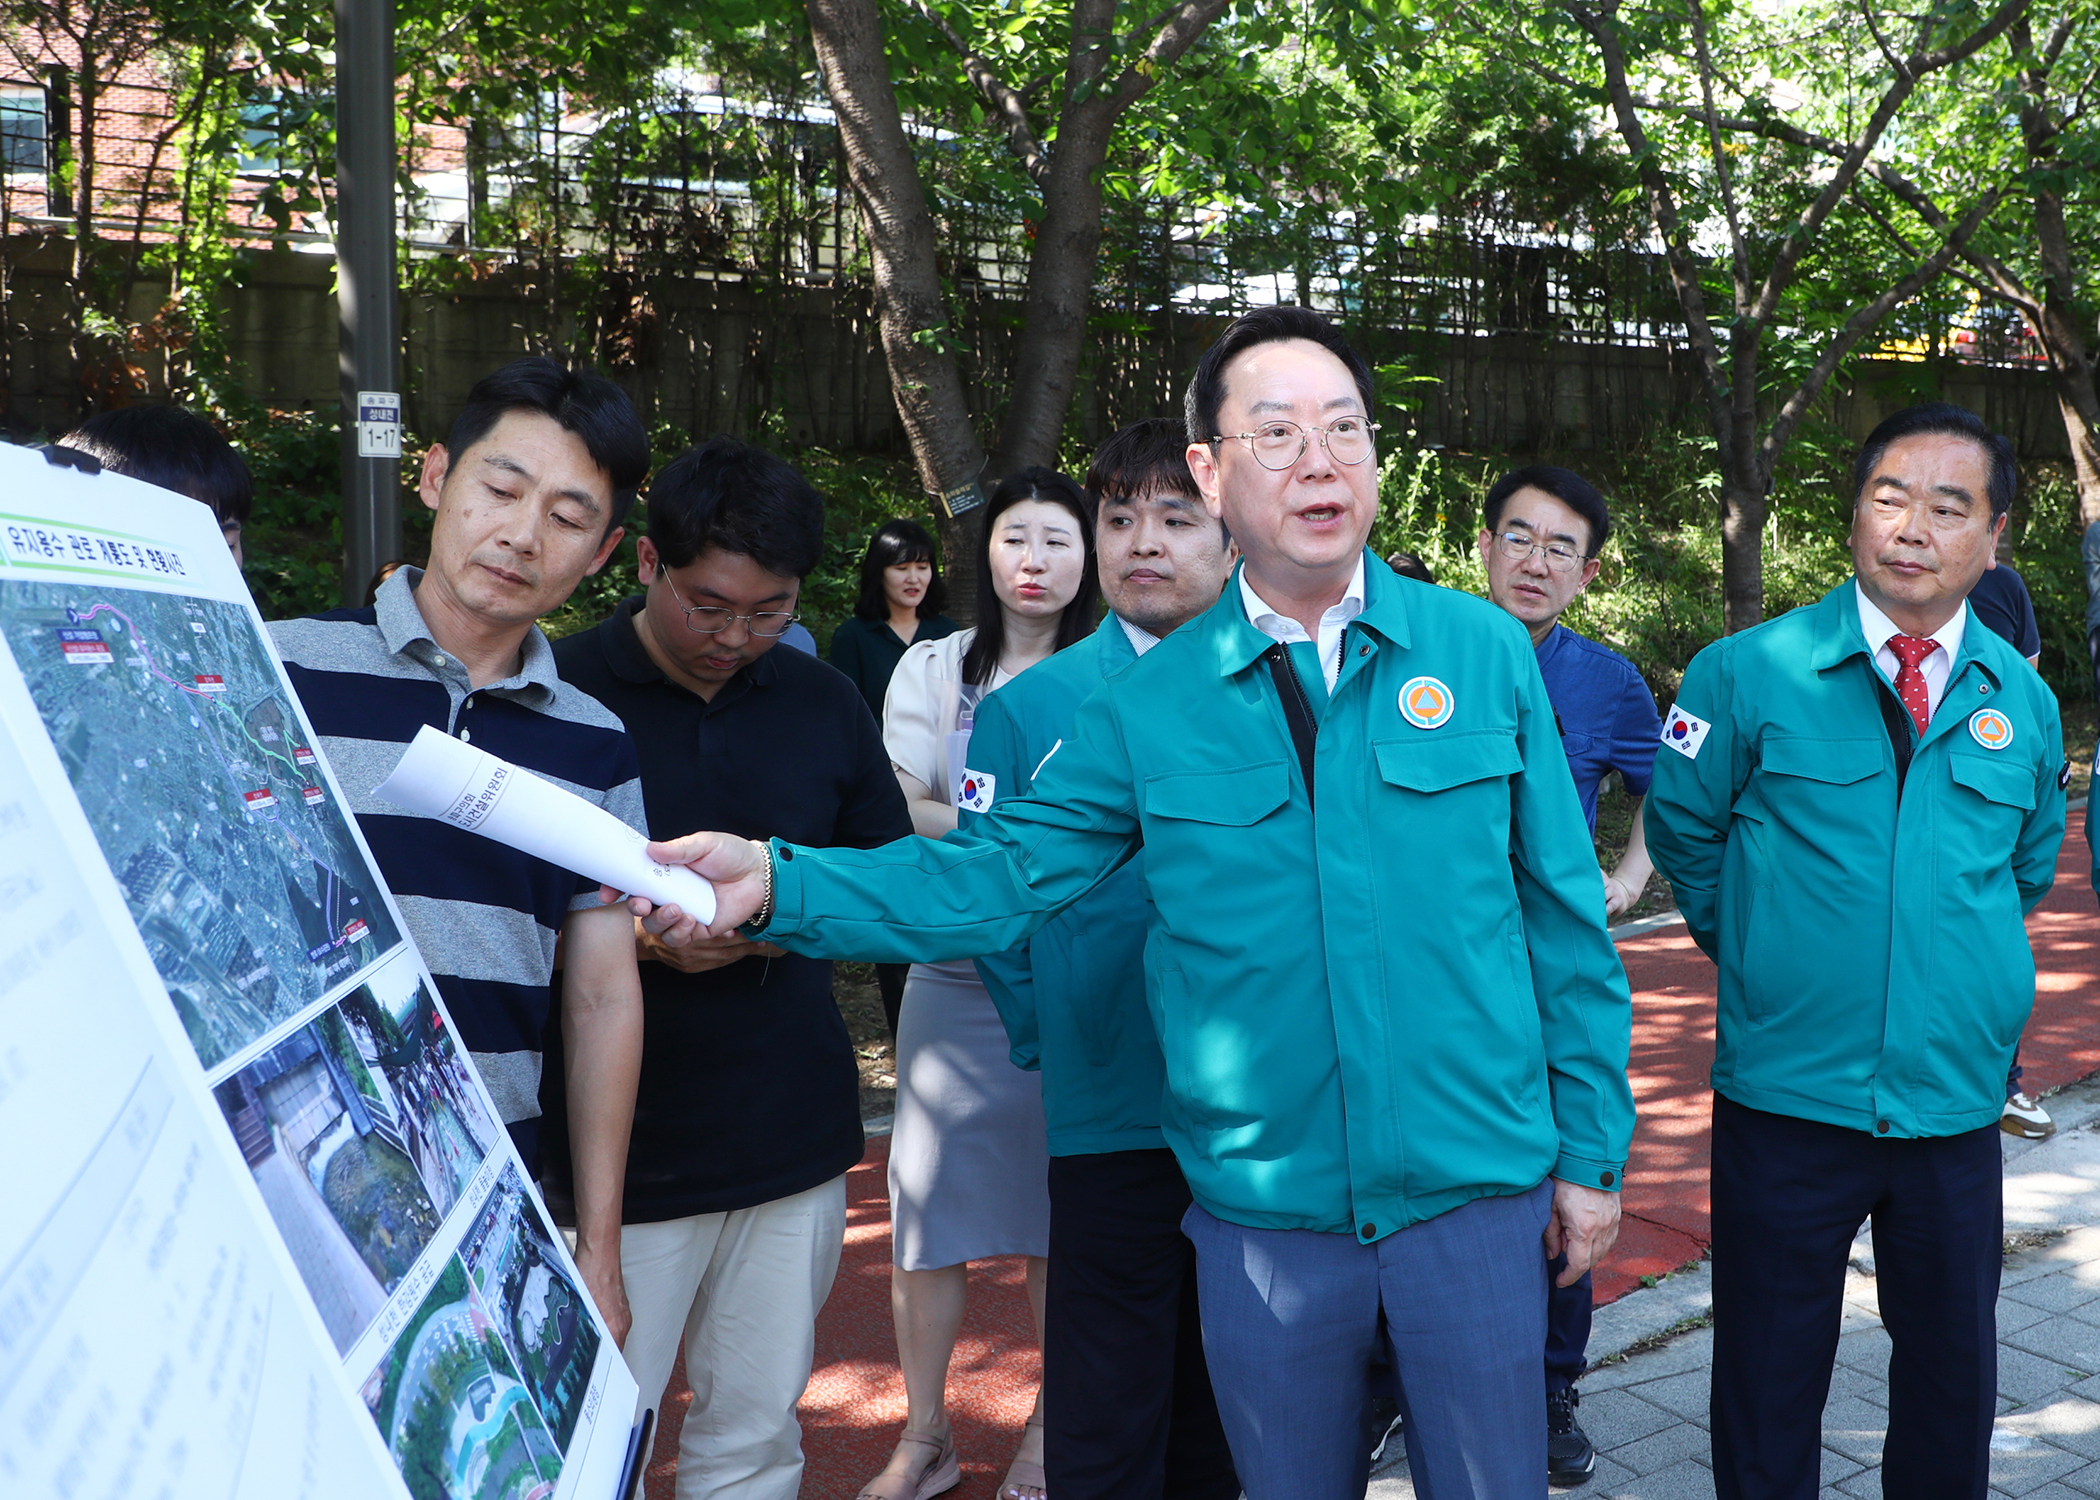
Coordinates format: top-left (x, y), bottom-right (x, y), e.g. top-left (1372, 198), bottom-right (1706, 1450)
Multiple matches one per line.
top-left (0, 447), bottom-right (636, 1500)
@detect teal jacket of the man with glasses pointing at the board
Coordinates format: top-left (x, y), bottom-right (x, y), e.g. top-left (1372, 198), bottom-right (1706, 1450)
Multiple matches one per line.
top-left (764, 555), bottom-right (1634, 1242)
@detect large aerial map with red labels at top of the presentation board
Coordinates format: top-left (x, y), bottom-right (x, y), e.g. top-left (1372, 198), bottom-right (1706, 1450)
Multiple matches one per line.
top-left (0, 582), bottom-right (401, 1067)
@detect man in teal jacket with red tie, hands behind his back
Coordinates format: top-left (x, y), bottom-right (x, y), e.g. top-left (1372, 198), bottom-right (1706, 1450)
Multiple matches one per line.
top-left (1649, 405), bottom-right (2069, 1500)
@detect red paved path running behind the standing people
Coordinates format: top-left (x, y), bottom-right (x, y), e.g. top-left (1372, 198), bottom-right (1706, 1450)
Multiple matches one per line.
top-left (647, 815), bottom-right (2100, 1500)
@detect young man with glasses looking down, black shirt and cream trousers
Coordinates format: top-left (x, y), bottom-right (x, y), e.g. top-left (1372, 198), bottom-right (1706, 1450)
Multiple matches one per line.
top-left (542, 437), bottom-right (911, 1500)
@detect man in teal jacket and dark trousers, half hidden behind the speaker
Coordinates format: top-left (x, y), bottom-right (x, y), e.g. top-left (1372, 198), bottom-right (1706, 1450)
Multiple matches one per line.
top-left (962, 418), bottom-right (1239, 1500)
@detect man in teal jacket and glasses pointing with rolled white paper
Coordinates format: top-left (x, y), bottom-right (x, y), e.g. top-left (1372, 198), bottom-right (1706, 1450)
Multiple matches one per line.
top-left (636, 307), bottom-right (1634, 1500)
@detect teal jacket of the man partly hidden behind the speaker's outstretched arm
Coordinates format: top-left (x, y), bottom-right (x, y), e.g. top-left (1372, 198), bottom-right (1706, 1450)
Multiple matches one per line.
top-left (960, 613), bottom-right (1166, 1155)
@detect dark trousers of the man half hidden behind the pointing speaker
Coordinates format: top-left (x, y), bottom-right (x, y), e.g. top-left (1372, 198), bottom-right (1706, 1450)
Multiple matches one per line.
top-left (1044, 1149), bottom-right (1239, 1500)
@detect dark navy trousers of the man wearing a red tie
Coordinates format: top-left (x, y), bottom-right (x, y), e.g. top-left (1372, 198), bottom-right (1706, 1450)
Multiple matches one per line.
top-left (1714, 1095), bottom-right (2003, 1500)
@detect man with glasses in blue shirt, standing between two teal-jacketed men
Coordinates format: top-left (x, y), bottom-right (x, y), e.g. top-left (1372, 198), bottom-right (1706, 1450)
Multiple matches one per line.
top-left (1481, 464), bottom-right (1663, 1485)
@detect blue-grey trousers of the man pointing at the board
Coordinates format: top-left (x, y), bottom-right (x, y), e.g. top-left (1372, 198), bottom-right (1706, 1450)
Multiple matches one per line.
top-left (1182, 1181), bottom-right (1552, 1500)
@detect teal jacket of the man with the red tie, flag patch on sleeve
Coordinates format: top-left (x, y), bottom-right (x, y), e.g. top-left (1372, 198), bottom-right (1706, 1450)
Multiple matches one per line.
top-left (1649, 582), bottom-right (2064, 1137)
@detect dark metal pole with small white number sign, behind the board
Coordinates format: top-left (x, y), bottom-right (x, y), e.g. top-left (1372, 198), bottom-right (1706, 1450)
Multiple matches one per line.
top-left (336, 0), bottom-right (401, 605)
